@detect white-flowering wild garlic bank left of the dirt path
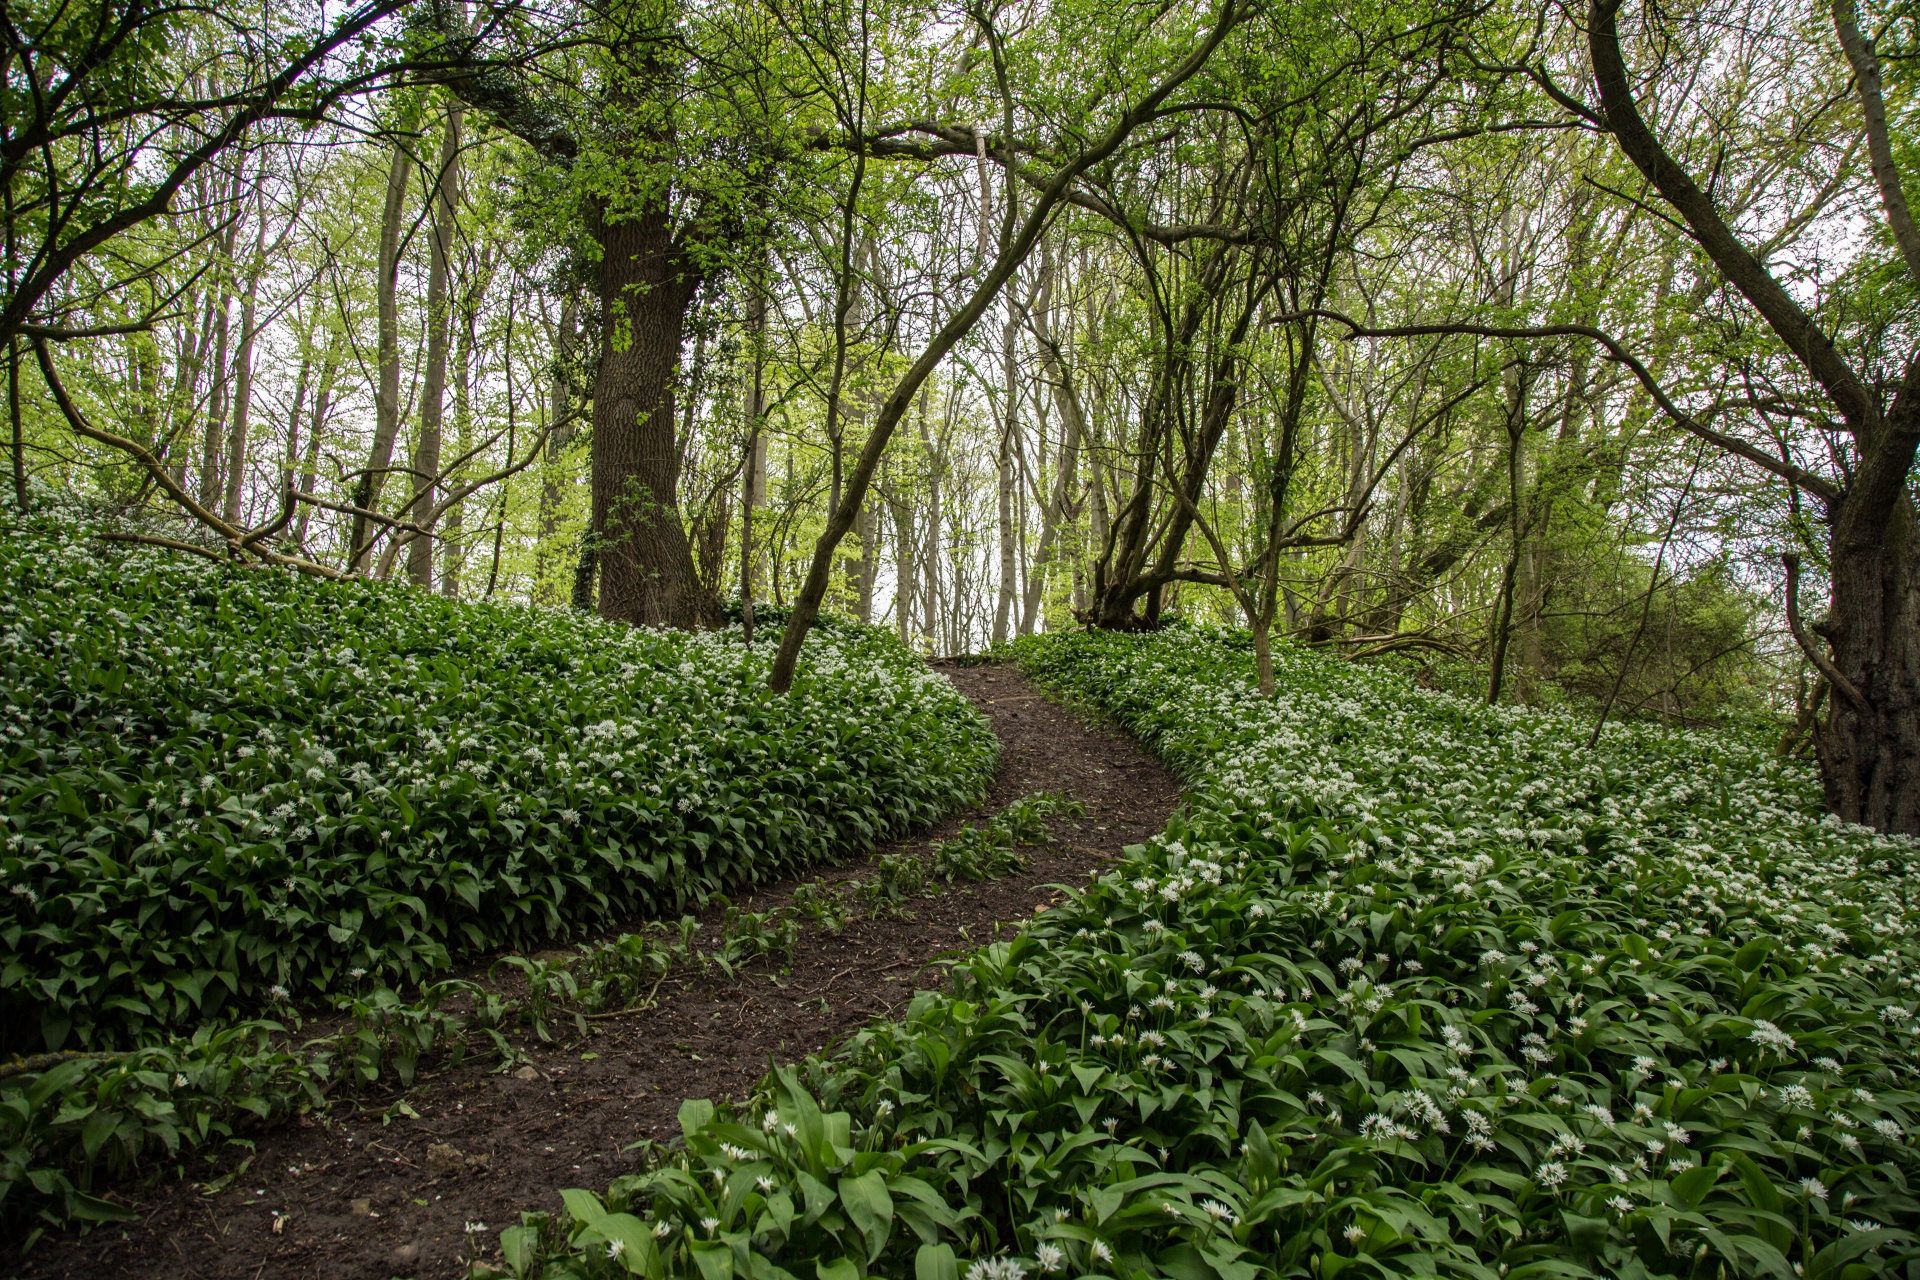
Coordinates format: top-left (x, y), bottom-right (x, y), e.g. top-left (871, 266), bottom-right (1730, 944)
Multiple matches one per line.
top-left (0, 516), bottom-right (996, 1243)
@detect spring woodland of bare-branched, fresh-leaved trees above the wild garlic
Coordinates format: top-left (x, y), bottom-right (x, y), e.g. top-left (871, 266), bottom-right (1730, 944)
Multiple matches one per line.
top-left (11, 0), bottom-right (1920, 831)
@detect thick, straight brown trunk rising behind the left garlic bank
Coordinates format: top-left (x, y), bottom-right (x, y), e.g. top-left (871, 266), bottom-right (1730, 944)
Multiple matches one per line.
top-left (576, 209), bottom-right (718, 628)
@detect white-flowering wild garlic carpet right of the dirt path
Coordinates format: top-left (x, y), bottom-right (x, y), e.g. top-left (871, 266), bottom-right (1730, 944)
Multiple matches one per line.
top-left (501, 631), bottom-right (1920, 1280)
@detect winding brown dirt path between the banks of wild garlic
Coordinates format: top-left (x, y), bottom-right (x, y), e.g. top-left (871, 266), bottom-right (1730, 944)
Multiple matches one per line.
top-left (21, 666), bottom-right (1179, 1280)
